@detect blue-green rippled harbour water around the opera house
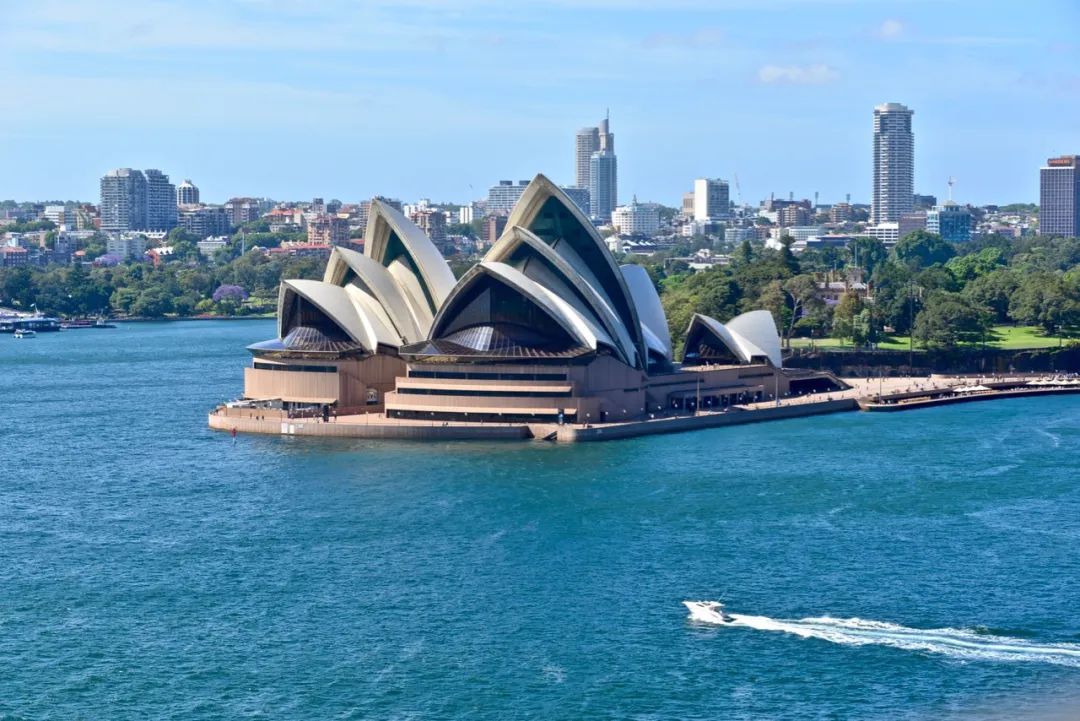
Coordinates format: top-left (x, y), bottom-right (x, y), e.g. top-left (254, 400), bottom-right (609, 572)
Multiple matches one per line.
top-left (0, 322), bottom-right (1080, 719)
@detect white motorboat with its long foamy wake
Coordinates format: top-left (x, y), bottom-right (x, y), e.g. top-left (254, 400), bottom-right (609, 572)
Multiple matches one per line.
top-left (687, 604), bottom-right (1080, 668)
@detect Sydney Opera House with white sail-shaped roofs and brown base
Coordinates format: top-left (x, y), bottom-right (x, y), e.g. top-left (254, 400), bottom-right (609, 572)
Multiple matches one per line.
top-left (234, 175), bottom-right (821, 424)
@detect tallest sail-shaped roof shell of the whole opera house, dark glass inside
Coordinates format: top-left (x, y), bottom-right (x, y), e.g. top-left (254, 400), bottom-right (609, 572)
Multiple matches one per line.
top-left (507, 175), bottom-right (646, 367)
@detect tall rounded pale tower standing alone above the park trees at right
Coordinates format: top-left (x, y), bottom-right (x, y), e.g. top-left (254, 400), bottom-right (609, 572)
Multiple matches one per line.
top-left (870, 103), bottom-right (915, 225)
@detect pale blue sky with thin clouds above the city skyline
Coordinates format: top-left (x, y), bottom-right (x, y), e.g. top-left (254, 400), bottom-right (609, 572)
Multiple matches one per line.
top-left (0, 0), bottom-right (1080, 205)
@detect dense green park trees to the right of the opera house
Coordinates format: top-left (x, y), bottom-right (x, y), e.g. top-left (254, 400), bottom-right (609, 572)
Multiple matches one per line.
top-left (629, 231), bottom-right (1080, 348)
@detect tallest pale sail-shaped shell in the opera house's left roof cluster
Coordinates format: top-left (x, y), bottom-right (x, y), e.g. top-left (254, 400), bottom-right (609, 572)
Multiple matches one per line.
top-left (364, 199), bottom-right (454, 316)
